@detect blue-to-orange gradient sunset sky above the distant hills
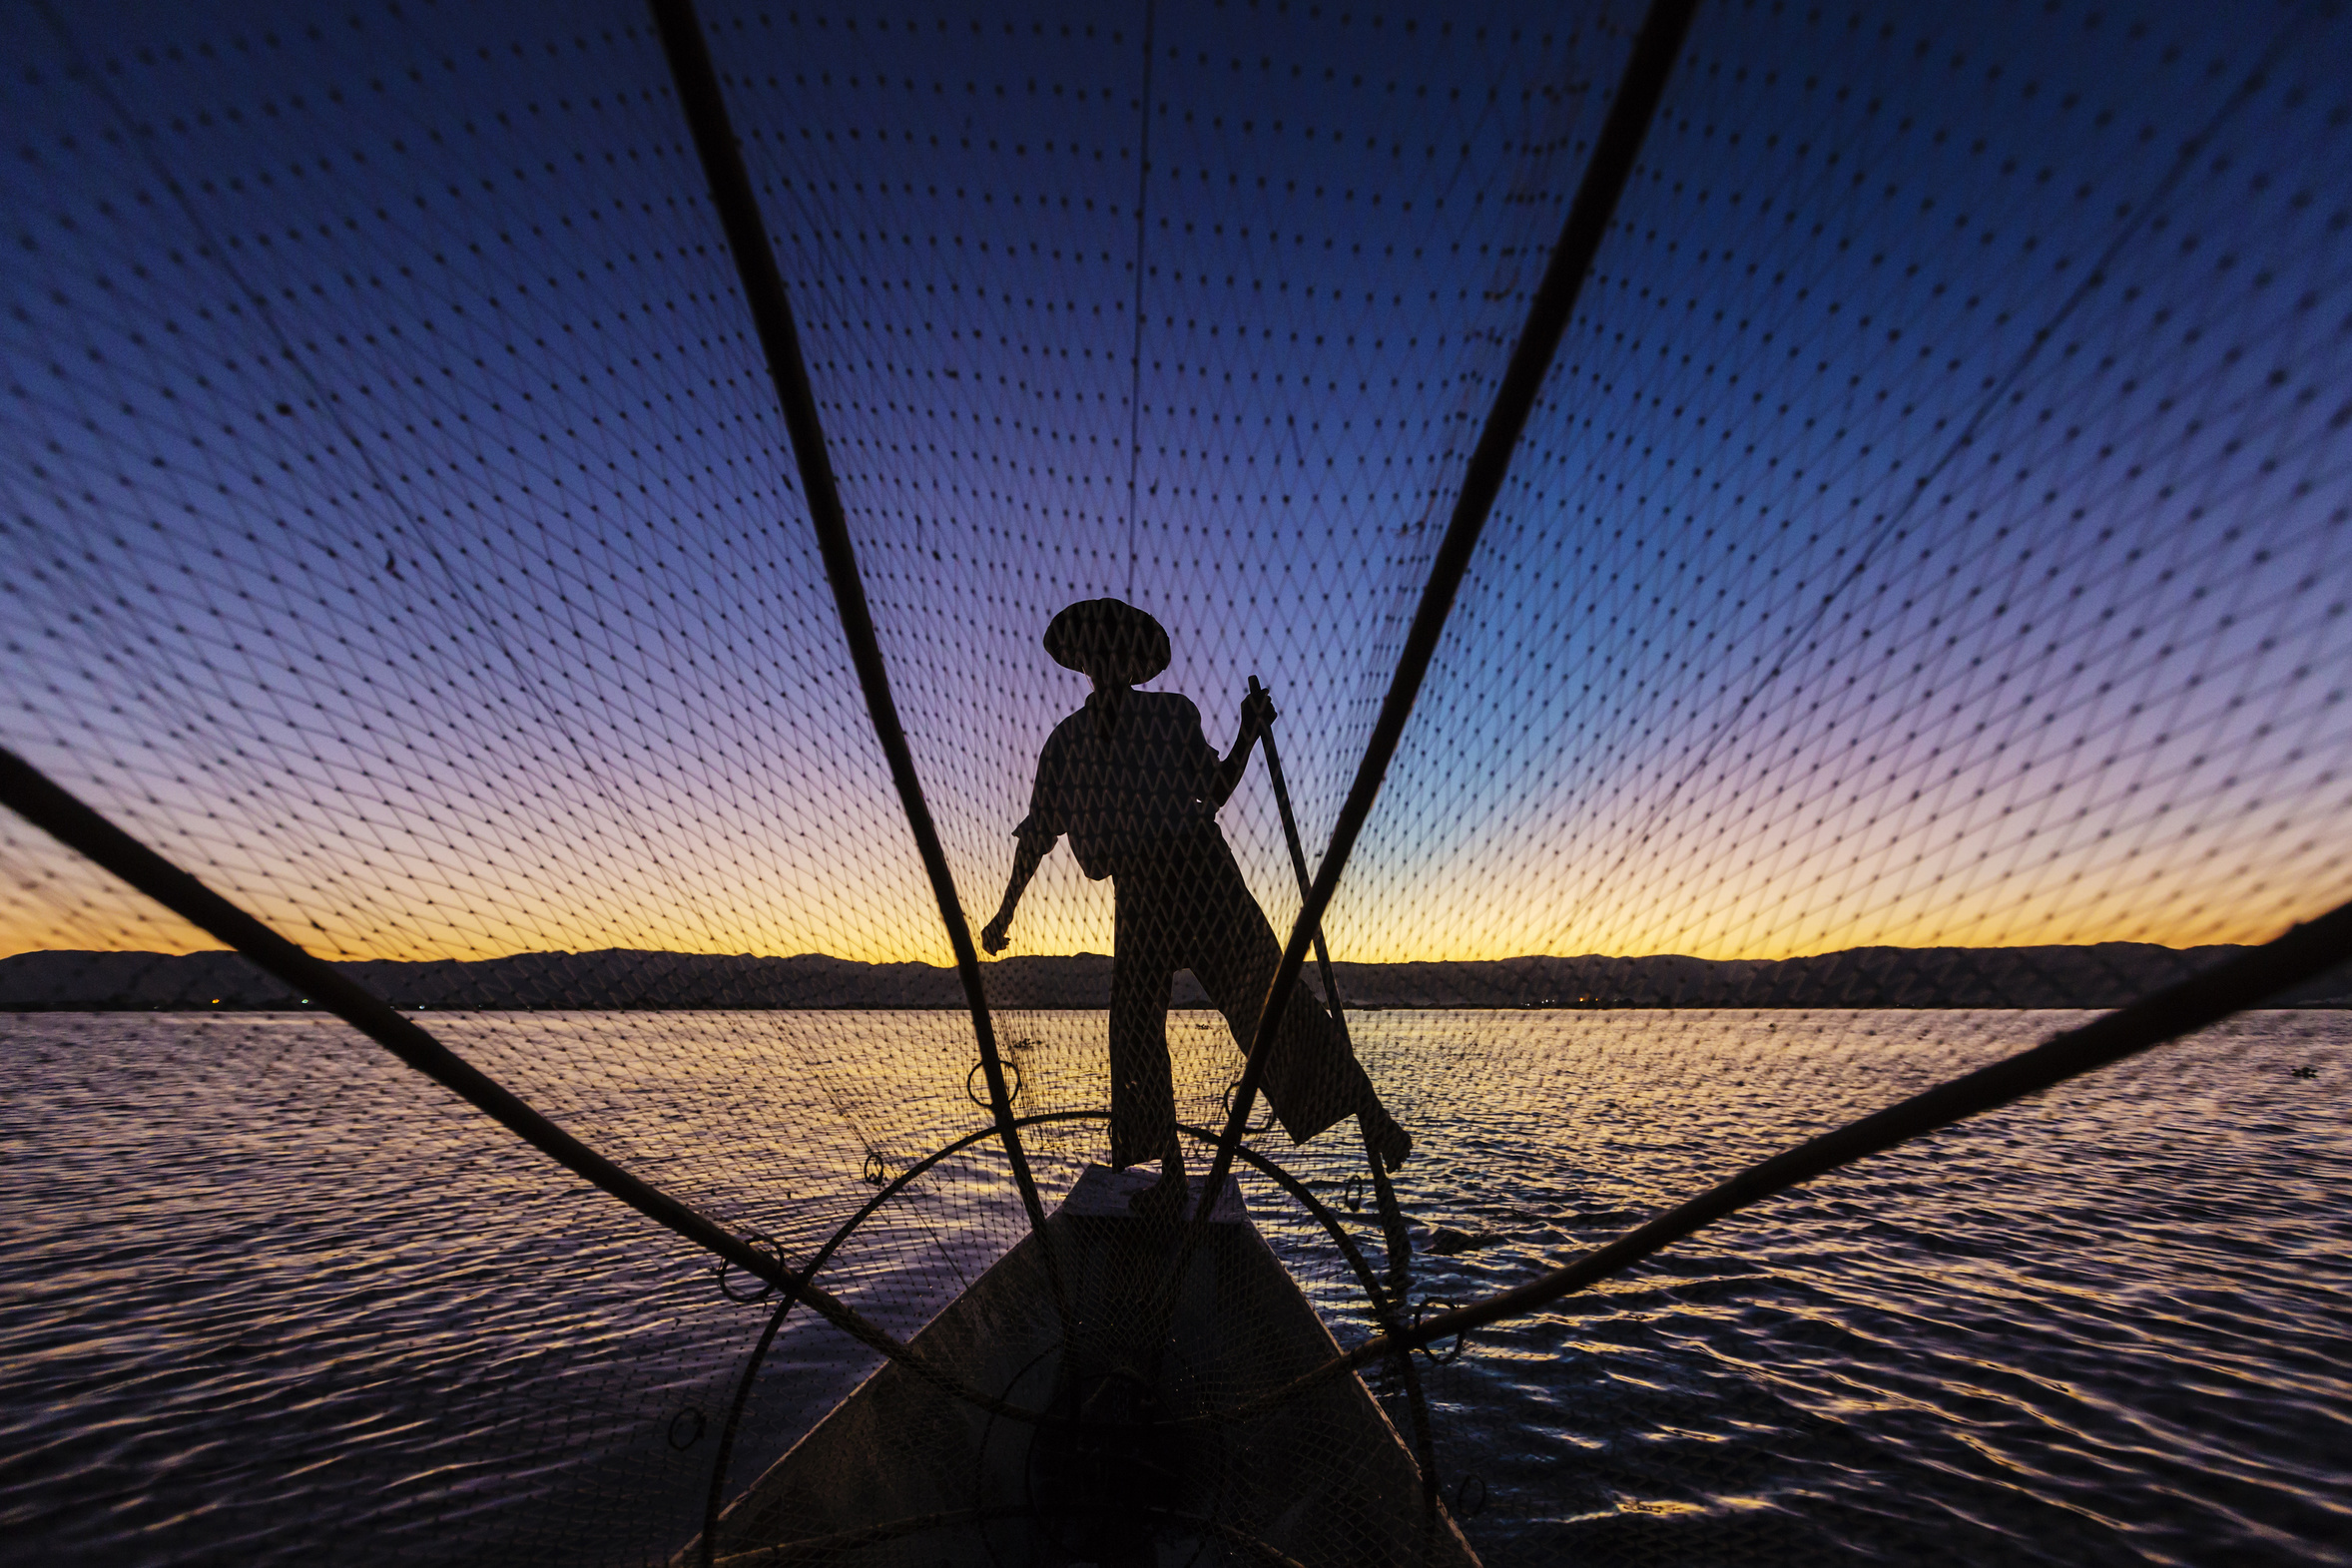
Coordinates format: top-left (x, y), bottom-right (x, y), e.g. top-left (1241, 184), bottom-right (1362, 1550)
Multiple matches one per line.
top-left (0, 5), bottom-right (2352, 961)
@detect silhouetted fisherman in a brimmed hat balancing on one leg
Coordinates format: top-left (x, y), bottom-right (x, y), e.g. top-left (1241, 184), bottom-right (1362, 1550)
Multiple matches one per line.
top-left (980, 600), bottom-right (1414, 1216)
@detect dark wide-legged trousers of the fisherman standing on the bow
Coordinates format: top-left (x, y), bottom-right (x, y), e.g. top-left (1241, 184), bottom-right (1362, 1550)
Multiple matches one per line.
top-left (1110, 820), bottom-right (1374, 1169)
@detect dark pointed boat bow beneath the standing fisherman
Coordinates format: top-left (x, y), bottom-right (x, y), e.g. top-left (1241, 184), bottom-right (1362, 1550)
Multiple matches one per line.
top-left (678, 1166), bottom-right (1477, 1568)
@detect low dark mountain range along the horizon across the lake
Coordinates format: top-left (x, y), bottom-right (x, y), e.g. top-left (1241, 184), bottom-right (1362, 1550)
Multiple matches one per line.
top-left (0, 942), bottom-right (2352, 1011)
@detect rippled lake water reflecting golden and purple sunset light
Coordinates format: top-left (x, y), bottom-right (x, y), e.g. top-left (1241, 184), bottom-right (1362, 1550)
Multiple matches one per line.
top-left (0, 1013), bottom-right (2352, 1566)
